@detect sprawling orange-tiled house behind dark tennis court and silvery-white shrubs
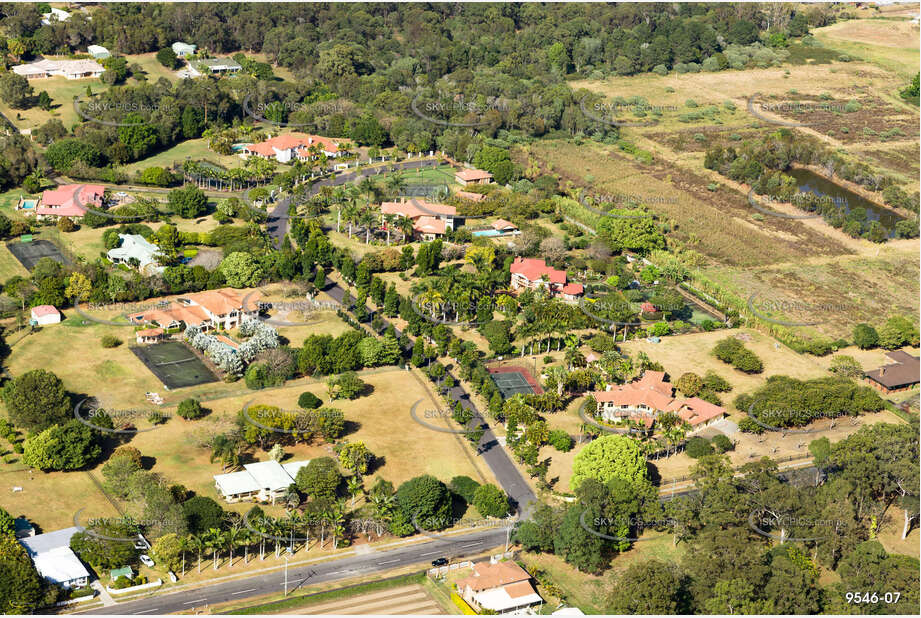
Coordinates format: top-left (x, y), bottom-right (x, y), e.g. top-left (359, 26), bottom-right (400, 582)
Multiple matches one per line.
top-left (128, 288), bottom-right (262, 330)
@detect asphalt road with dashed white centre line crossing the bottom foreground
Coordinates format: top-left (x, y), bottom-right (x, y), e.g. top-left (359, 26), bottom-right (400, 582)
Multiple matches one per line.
top-left (80, 528), bottom-right (506, 615)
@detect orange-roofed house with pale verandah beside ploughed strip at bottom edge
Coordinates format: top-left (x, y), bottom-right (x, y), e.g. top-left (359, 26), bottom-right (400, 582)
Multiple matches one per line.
top-left (456, 562), bottom-right (544, 614)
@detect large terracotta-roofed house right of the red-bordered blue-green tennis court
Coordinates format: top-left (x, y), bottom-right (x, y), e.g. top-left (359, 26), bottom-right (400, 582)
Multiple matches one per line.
top-left (592, 371), bottom-right (726, 433)
